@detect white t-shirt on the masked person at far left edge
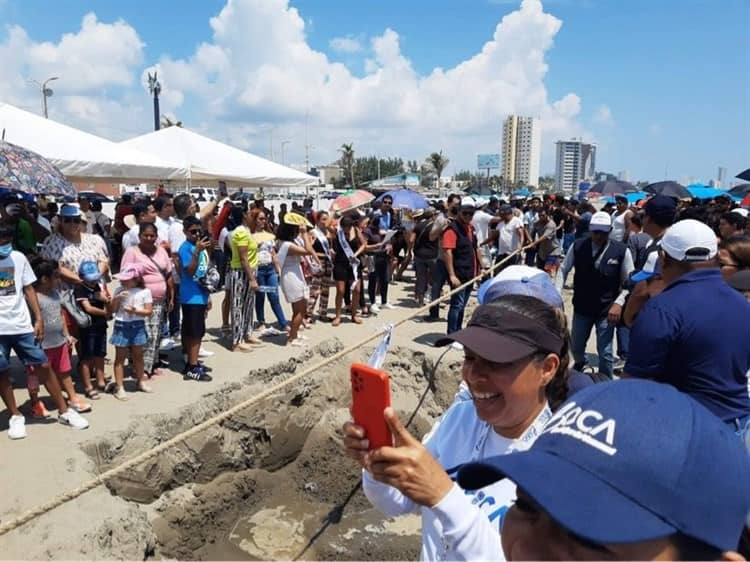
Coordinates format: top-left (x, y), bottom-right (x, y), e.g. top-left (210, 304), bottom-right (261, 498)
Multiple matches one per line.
top-left (0, 250), bottom-right (36, 334)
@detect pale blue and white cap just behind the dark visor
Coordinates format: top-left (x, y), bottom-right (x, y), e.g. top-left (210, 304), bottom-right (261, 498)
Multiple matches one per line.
top-left (477, 265), bottom-right (563, 310)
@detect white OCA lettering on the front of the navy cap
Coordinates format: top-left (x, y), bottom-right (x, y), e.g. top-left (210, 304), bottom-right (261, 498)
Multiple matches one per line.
top-left (542, 402), bottom-right (617, 456)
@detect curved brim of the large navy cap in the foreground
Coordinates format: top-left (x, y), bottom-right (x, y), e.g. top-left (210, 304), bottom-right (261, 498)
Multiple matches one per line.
top-left (458, 448), bottom-right (677, 544)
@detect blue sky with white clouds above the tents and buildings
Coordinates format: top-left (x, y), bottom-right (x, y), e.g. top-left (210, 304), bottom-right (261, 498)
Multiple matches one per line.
top-left (0, 0), bottom-right (750, 182)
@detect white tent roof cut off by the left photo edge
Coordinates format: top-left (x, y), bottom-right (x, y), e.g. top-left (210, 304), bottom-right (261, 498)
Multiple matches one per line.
top-left (0, 104), bottom-right (188, 183)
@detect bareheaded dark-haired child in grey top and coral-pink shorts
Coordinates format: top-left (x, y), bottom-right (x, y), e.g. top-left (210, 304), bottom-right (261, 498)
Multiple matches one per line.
top-left (29, 259), bottom-right (91, 417)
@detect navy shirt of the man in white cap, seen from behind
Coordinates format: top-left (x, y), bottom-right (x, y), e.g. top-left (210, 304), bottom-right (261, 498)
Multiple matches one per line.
top-left (625, 269), bottom-right (750, 422)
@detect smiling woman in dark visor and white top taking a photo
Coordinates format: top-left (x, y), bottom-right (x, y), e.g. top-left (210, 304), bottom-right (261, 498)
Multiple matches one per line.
top-left (344, 295), bottom-right (570, 560)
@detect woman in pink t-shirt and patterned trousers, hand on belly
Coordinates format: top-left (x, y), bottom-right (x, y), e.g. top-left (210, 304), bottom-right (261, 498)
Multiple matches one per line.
top-left (120, 222), bottom-right (174, 376)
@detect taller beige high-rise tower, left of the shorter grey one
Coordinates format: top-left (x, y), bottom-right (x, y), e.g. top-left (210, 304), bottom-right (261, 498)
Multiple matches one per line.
top-left (501, 115), bottom-right (542, 186)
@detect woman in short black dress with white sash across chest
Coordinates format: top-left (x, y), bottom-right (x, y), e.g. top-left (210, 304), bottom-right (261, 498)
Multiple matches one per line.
top-left (332, 213), bottom-right (367, 326)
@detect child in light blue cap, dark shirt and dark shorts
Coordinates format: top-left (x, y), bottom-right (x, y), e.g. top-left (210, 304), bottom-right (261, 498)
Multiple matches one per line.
top-left (73, 261), bottom-right (111, 400)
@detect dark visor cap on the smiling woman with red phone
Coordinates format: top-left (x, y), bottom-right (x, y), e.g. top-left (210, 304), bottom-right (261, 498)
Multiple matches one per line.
top-left (435, 304), bottom-right (563, 363)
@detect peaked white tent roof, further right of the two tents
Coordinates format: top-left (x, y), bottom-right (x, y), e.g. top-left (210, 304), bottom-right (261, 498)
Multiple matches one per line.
top-left (120, 127), bottom-right (318, 187)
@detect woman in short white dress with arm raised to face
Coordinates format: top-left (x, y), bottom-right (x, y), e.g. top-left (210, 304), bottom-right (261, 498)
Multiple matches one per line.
top-left (276, 220), bottom-right (318, 347)
